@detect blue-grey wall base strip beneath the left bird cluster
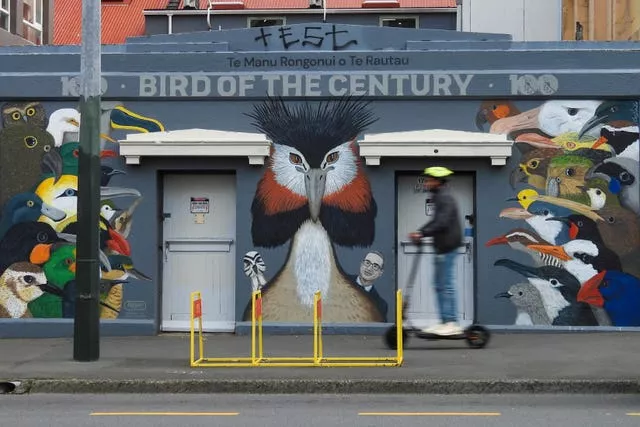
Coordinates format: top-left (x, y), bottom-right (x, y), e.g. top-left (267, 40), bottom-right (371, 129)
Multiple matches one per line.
top-left (0, 319), bottom-right (158, 338)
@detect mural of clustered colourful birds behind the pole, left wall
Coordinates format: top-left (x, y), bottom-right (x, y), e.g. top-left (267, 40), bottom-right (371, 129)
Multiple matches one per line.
top-left (0, 101), bottom-right (164, 318)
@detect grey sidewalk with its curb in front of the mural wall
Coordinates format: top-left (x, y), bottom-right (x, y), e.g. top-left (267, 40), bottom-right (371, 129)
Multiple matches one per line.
top-left (0, 332), bottom-right (640, 394)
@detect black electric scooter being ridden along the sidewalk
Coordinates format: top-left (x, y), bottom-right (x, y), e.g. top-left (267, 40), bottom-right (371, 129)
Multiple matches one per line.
top-left (384, 237), bottom-right (491, 350)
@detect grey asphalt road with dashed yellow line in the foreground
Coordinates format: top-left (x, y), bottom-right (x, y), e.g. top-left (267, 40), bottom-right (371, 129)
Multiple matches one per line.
top-left (0, 394), bottom-right (640, 427)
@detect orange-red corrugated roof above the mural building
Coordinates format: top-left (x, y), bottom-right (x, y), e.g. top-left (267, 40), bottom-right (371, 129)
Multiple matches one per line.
top-left (53, 0), bottom-right (456, 45)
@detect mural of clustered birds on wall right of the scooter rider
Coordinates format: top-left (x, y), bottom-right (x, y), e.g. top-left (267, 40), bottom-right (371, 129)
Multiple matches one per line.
top-left (484, 100), bottom-right (640, 326)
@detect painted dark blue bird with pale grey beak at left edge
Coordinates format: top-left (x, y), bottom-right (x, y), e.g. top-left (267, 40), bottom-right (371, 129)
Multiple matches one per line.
top-left (0, 193), bottom-right (66, 240)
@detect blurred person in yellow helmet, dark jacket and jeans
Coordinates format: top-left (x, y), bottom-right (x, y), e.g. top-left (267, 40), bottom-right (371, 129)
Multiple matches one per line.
top-left (409, 166), bottom-right (464, 336)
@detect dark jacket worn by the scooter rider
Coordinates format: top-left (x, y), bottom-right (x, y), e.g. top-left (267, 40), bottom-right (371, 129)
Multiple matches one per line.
top-left (420, 186), bottom-right (463, 254)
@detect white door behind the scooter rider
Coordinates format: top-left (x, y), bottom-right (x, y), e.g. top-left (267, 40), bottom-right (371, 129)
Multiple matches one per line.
top-left (397, 174), bottom-right (474, 328)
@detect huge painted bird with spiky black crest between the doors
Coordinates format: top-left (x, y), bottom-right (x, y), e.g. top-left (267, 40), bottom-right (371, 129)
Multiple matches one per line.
top-left (243, 96), bottom-right (383, 322)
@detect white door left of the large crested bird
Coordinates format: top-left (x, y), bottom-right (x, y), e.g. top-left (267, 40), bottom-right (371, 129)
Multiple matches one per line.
top-left (161, 174), bottom-right (236, 332)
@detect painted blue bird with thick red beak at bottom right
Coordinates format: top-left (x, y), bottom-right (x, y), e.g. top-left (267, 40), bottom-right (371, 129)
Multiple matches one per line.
top-left (578, 270), bottom-right (640, 326)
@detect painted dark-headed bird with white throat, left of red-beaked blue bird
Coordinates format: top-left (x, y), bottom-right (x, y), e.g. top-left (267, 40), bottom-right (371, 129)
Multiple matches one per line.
top-left (494, 259), bottom-right (598, 326)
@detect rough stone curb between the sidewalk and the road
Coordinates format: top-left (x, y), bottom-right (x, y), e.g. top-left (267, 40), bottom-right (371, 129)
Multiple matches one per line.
top-left (12, 379), bottom-right (640, 394)
